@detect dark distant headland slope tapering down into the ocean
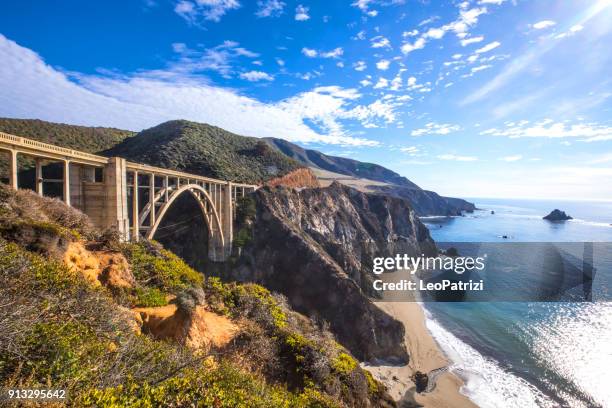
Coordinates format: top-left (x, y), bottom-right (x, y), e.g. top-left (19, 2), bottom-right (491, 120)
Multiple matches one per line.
top-left (370, 186), bottom-right (476, 217)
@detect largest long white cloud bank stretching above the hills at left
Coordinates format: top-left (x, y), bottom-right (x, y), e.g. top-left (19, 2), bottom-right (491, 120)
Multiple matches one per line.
top-left (0, 35), bottom-right (382, 146)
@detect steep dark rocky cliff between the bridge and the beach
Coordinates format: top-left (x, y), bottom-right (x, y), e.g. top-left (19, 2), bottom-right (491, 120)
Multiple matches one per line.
top-left (233, 183), bottom-right (435, 361)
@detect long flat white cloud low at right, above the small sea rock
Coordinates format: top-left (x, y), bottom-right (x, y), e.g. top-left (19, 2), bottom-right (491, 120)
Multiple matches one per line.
top-left (480, 119), bottom-right (612, 142)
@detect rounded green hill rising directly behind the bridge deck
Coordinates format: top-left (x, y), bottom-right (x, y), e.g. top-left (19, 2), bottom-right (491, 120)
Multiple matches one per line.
top-left (103, 120), bottom-right (304, 183)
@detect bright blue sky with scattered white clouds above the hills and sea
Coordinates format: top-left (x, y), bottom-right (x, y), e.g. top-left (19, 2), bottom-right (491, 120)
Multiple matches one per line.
top-left (0, 0), bottom-right (612, 199)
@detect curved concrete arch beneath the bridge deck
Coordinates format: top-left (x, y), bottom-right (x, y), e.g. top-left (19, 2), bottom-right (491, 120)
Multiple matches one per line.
top-left (143, 184), bottom-right (227, 257)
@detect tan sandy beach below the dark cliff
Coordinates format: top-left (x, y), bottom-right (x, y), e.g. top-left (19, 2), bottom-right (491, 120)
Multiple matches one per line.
top-left (363, 271), bottom-right (476, 408)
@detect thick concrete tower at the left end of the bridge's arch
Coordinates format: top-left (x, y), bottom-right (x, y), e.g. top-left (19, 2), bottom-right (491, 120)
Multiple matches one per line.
top-left (104, 157), bottom-right (130, 241)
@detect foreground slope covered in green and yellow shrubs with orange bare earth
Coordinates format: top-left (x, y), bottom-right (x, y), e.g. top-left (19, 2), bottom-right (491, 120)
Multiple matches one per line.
top-left (0, 185), bottom-right (394, 407)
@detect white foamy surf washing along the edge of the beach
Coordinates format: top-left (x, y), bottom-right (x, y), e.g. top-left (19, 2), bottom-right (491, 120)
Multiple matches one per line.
top-left (423, 308), bottom-right (556, 408)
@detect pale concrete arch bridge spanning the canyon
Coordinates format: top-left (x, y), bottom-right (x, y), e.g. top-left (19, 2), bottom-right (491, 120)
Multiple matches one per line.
top-left (0, 132), bottom-right (257, 261)
